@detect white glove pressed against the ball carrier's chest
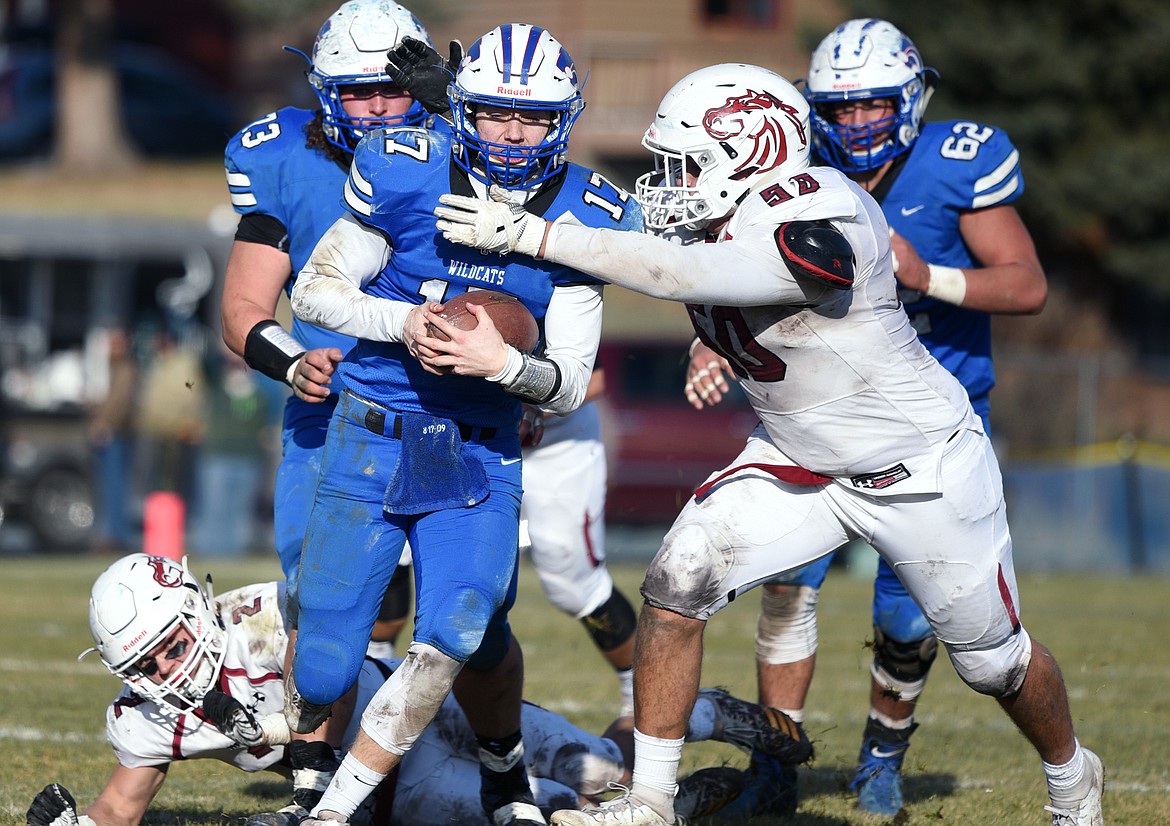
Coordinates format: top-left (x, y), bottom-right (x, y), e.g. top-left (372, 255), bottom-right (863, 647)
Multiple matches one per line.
top-left (434, 186), bottom-right (549, 257)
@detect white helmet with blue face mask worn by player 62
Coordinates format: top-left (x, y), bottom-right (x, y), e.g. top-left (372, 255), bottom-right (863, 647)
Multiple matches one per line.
top-left (805, 18), bottom-right (938, 172)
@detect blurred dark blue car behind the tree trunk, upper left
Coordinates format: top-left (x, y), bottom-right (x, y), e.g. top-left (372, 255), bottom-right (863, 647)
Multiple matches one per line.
top-left (0, 43), bottom-right (236, 161)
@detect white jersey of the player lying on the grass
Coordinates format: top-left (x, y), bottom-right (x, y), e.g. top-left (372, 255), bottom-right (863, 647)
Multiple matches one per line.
top-left (105, 583), bottom-right (288, 771)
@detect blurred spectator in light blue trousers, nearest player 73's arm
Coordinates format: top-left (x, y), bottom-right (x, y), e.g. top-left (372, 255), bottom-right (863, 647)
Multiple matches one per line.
top-left (192, 346), bottom-right (283, 556)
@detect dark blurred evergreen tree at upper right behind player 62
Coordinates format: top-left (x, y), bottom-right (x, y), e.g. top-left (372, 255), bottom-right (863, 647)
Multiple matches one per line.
top-left (837, 0), bottom-right (1170, 298)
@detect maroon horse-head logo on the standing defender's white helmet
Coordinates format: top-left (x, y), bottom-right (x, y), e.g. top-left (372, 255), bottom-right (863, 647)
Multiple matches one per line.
top-left (703, 89), bottom-right (808, 180)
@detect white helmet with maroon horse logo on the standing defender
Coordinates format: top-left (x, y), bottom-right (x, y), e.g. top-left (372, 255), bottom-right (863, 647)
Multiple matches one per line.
top-left (638, 63), bottom-right (808, 232)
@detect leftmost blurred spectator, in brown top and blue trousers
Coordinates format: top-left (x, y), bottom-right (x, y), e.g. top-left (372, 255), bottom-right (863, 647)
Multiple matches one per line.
top-left (88, 328), bottom-right (138, 552)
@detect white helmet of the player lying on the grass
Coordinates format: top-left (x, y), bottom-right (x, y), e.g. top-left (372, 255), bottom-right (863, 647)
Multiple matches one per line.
top-left (78, 553), bottom-right (227, 711)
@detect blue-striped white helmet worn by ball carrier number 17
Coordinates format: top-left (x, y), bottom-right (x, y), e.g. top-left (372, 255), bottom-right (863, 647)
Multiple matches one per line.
top-left (447, 23), bottom-right (585, 190)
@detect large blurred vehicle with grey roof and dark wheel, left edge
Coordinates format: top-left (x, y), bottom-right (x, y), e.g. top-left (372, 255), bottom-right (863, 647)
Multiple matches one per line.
top-left (0, 211), bottom-right (232, 552)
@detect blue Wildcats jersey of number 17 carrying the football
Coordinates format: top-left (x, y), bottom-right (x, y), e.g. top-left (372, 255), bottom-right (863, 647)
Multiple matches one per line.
top-left (338, 128), bottom-right (642, 428)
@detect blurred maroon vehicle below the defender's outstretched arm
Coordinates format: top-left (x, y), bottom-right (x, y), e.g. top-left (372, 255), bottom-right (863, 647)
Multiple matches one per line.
top-left (598, 340), bottom-right (758, 524)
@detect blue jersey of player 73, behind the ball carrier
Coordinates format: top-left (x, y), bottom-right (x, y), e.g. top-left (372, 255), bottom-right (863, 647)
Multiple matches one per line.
top-left (223, 106), bottom-right (353, 353)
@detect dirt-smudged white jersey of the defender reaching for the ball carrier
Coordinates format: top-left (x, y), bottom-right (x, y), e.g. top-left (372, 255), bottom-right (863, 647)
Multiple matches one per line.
top-left (689, 167), bottom-right (982, 494)
